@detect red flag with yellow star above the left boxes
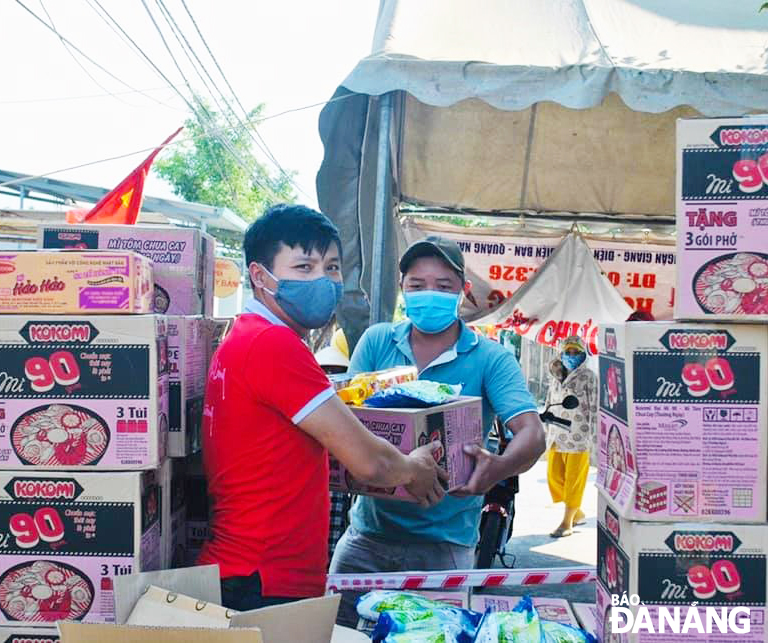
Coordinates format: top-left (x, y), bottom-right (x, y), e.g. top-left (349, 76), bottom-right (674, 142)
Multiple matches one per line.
top-left (67, 127), bottom-right (184, 225)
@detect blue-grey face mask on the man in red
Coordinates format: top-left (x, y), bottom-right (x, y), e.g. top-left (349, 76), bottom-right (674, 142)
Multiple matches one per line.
top-left (264, 268), bottom-right (342, 328)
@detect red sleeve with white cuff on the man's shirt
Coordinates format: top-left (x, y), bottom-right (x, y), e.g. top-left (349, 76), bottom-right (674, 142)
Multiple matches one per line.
top-left (246, 326), bottom-right (335, 424)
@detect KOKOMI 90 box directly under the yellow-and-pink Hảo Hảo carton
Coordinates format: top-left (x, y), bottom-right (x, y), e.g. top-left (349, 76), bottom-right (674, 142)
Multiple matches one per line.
top-left (0, 315), bottom-right (168, 469)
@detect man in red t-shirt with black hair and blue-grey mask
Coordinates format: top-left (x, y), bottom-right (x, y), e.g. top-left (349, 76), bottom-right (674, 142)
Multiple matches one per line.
top-left (198, 205), bottom-right (446, 610)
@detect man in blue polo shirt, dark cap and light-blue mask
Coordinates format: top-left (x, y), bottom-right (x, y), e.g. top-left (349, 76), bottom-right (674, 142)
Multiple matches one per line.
top-left (330, 237), bottom-right (545, 624)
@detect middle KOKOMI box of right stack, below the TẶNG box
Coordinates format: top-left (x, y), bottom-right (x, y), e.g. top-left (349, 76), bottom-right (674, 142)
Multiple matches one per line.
top-left (597, 322), bottom-right (768, 523)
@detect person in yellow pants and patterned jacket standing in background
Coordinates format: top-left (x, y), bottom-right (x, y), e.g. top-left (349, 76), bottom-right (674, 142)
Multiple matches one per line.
top-left (547, 336), bottom-right (597, 538)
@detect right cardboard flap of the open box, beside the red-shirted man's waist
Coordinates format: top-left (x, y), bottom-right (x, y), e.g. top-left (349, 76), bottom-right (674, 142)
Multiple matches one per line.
top-left (230, 594), bottom-right (341, 643)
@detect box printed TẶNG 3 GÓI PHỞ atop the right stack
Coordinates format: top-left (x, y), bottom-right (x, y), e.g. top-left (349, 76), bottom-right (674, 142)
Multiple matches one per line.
top-left (675, 116), bottom-right (768, 321)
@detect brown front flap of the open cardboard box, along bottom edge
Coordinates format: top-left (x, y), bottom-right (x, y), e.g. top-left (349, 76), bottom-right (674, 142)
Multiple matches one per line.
top-left (58, 622), bottom-right (260, 643)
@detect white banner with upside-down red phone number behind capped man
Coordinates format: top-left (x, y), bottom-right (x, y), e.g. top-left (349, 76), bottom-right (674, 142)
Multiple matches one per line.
top-left (403, 222), bottom-right (675, 320)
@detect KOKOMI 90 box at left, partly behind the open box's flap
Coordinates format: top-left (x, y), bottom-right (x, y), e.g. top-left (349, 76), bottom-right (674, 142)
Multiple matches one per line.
top-left (0, 470), bottom-right (161, 626)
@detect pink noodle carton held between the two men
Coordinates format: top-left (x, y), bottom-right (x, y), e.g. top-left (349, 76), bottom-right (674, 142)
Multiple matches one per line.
top-left (330, 396), bottom-right (483, 502)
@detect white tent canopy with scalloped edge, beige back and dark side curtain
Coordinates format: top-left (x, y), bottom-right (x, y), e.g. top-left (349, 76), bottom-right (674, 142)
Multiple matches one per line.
top-left (317, 0), bottom-right (768, 344)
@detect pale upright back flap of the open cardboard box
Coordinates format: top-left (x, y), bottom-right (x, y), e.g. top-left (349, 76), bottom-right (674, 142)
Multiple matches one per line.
top-left (115, 565), bottom-right (221, 624)
